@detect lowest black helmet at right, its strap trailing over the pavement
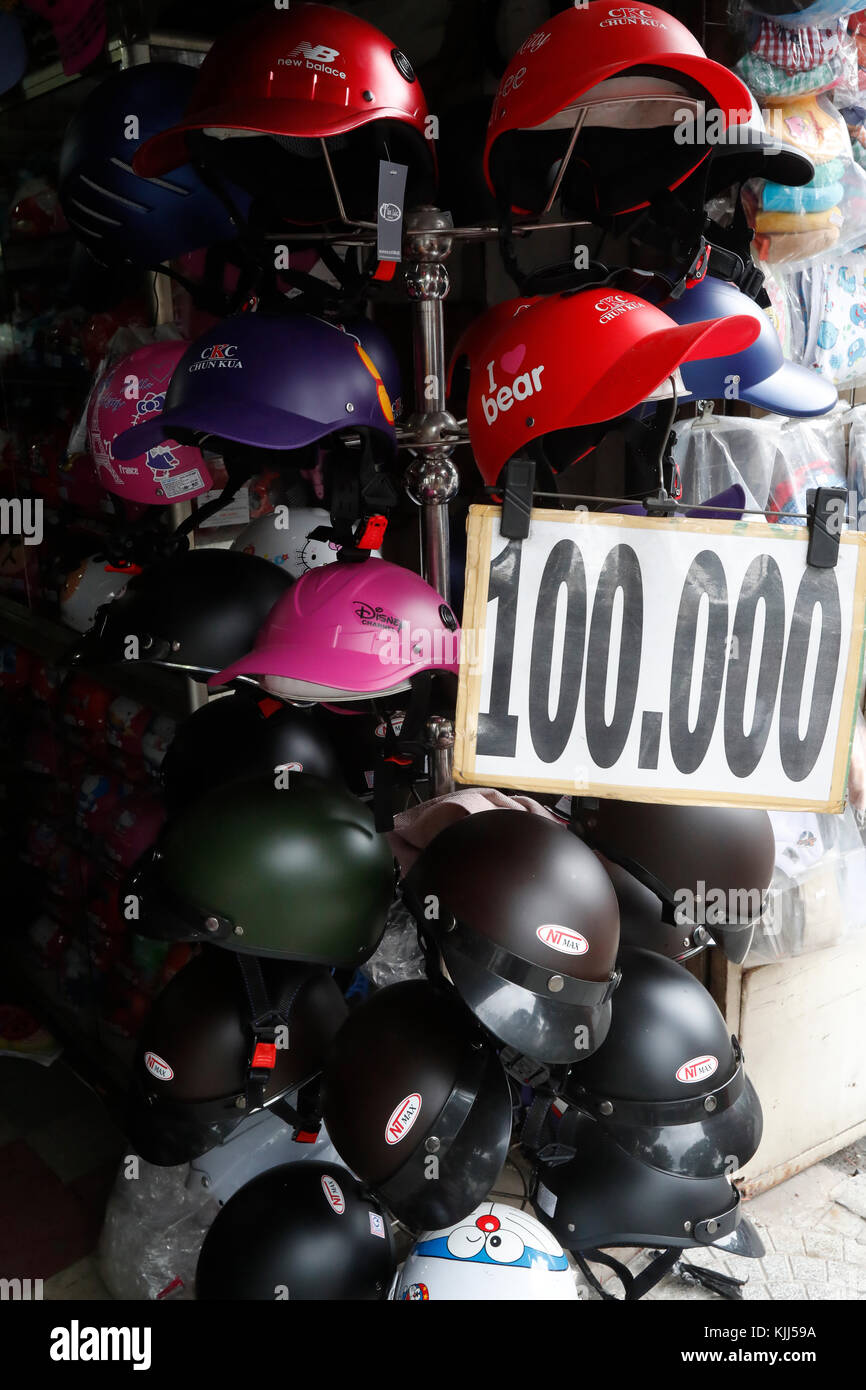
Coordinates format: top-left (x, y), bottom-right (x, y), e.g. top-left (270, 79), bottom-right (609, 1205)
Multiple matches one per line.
top-left (532, 1111), bottom-right (765, 1298)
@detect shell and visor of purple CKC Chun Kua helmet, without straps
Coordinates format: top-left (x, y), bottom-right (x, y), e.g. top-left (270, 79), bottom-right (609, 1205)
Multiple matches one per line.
top-left (114, 314), bottom-right (396, 460)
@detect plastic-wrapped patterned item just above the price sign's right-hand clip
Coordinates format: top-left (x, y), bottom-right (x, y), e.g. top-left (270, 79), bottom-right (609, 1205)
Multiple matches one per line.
top-left (766, 410), bottom-right (848, 527)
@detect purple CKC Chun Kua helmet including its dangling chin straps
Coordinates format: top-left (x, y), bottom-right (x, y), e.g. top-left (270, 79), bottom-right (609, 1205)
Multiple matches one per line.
top-left (114, 314), bottom-right (398, 536)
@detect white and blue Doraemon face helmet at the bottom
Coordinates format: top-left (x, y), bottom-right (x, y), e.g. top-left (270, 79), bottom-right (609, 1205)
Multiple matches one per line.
top-left (391, 1202), bottom-right (580, 1302)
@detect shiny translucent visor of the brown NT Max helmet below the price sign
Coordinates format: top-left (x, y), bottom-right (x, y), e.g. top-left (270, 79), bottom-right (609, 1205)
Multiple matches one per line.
top-left (441, 937), bottom-right (610, 1065)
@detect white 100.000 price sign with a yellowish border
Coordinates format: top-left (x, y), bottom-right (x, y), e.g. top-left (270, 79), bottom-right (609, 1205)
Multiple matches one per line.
top-left (455, 506), bottom-right (866, 810)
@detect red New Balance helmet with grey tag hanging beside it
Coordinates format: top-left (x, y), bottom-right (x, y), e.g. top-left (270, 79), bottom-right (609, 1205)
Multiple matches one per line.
top-left (135, 4), bottom-right (435, 224)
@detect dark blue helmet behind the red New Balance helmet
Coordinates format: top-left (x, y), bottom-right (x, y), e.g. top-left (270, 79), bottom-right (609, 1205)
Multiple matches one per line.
top-left (60, 63), bottom-right (249, 265)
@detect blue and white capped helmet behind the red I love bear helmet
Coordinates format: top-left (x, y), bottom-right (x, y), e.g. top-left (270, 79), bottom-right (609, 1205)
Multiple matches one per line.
top-left (663, 275), bottom-right (839, 416)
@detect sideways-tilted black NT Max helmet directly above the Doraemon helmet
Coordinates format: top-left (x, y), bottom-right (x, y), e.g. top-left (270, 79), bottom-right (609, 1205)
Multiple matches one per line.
top-left (322, 980), bottom-right (512, 1230)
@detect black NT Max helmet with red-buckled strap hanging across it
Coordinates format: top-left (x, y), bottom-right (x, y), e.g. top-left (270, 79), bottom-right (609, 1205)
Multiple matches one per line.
top-left (126, 948), bottom-right (348, 1166)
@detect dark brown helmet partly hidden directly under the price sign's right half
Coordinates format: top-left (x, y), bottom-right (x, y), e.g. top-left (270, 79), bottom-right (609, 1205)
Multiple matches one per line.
top-left (573, 801), bottom-right (776, 963)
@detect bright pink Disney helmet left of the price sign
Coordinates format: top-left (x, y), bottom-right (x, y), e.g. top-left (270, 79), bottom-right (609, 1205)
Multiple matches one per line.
top-left (209, 559), bottom-right (460, 702)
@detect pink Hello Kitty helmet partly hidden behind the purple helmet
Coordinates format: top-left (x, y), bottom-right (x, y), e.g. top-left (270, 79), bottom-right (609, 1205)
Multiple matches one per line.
top-left (88, 339), bottom-right (211, 506)
